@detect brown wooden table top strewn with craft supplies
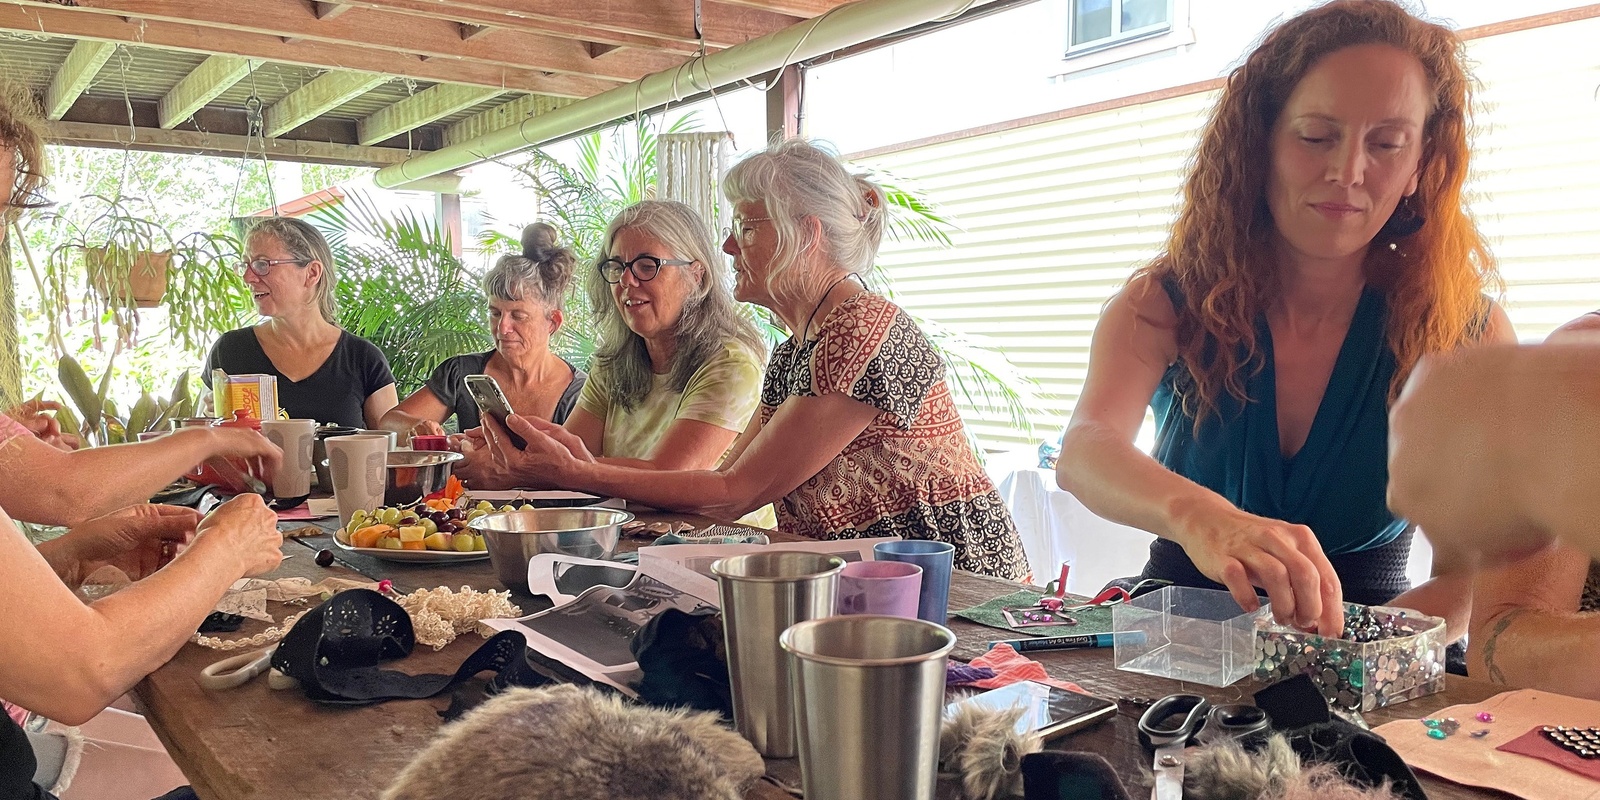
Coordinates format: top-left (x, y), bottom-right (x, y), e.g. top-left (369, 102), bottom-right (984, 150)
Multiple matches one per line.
top-left (134, 514), bottom-right (1506, 800)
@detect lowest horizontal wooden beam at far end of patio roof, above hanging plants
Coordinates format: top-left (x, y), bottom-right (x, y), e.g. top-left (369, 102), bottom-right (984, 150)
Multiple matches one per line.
top-left (45, 122), bottom-right (414, 166)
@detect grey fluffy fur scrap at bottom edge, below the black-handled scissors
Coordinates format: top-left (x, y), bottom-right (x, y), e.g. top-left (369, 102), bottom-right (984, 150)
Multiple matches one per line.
top-left (1184, 734), bottom-right (1400, 800)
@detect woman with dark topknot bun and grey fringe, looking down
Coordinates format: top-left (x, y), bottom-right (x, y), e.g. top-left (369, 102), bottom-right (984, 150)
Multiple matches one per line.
top-left (381, 222), bottom-right (587, 437)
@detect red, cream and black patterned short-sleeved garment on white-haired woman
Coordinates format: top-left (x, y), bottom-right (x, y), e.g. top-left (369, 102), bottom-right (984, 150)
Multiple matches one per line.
top-left (760, 293), bottom-right (1027, 581)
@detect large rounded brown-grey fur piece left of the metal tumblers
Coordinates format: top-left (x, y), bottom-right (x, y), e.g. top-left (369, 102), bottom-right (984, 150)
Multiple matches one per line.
top-left (382, 685), bottom-right (766, 800)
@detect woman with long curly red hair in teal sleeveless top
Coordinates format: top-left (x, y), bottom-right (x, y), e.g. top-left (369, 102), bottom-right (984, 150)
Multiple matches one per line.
top-left (1058, 0), bottom-right (1514, 632)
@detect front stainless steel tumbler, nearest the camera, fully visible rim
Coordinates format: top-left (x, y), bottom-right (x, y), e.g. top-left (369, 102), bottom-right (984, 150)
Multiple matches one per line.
top-left (779, 616), bottom-right (955, 800)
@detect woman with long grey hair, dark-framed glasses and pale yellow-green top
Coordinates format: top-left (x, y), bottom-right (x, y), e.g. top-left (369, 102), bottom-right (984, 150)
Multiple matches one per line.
top-left (462, 200), bottom-right (765, 488)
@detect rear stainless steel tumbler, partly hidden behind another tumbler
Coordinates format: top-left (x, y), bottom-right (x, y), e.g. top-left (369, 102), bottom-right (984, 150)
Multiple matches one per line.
top-left (710, 550), bottom-right (845, 758)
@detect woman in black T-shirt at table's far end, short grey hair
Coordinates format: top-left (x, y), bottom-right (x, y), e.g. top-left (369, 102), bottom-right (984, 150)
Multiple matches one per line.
top-left (200, 216), bottom-right (398, 427)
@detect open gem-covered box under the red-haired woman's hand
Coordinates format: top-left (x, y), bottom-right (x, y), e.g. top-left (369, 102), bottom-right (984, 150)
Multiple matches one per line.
top-left (1256, 603), bottom-right (1445, 710)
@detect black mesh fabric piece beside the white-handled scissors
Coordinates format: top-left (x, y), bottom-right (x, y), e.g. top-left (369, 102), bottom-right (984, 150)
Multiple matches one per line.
top-left (272, 589), bottom-right (549, 706)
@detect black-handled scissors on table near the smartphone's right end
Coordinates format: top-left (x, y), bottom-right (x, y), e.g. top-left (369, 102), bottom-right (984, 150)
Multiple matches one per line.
top-left (1139, 694), bottom-right (1272, 800)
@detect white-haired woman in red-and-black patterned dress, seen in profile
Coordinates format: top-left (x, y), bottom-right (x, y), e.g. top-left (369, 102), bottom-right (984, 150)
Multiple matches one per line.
top-left (480, 139), bottom-right (1027, 579)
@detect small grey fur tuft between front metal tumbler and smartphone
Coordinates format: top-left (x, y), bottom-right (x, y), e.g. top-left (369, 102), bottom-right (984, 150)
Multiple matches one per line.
top-left (939, 706), bottom-right (1043, 800)
